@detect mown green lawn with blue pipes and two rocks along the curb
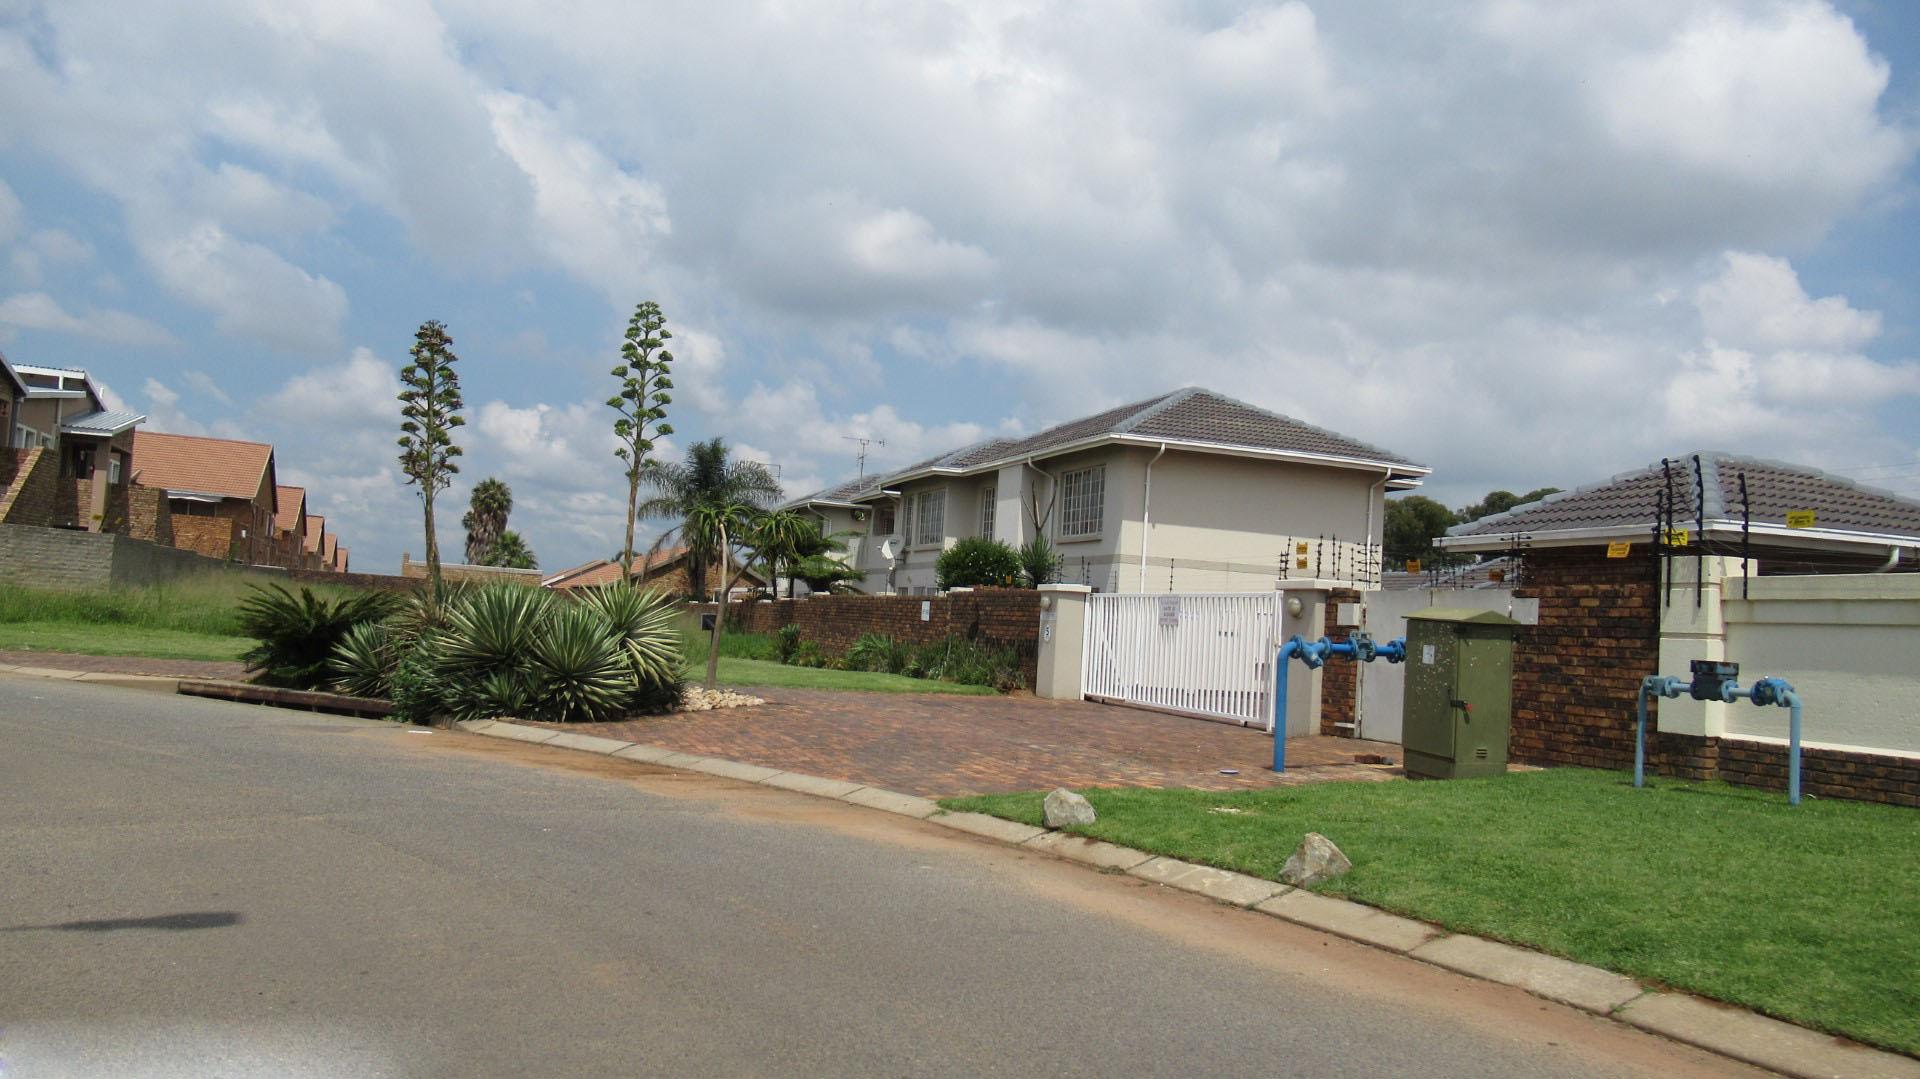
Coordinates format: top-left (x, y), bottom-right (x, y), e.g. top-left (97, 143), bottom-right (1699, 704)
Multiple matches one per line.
top-left (941, 768), bottom-right (1920, 1054)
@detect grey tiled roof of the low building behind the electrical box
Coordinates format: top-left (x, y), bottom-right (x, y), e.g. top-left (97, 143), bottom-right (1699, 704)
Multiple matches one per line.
top-left (1448, 451), bottom-right (1920, 538)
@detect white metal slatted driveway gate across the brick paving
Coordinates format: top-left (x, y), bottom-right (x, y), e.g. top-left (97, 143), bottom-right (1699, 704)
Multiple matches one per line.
top-left (1081, 591), bottom-right (1281, 730)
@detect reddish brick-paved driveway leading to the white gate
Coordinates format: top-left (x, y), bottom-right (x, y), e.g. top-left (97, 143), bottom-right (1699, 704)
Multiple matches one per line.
top-left (566, 689), bottom-right (1400, 797)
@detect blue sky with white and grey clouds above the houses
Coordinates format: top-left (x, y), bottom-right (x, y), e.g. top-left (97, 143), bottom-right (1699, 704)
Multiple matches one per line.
top-left (0, 0), bottom-right (1920, 572)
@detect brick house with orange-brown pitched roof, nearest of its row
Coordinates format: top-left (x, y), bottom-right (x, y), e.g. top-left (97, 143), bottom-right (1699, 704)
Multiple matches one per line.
top-left (132, 430), bottom-right (280, 564)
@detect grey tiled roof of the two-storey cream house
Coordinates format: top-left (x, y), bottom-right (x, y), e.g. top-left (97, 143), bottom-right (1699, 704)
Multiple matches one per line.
top-left (793, 386), bottom-right (1425, 505)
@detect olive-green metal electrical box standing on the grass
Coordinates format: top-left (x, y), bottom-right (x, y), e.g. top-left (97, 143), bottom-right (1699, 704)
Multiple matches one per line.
top-left (1400, 607), bottom-right (1521, 779)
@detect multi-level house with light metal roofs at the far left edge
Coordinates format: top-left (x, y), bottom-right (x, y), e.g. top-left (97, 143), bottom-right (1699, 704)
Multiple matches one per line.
top-left (0, 357), bottom-right (149, 538)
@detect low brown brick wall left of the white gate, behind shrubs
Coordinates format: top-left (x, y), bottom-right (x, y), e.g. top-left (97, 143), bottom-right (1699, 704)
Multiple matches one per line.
top-left (687, 587), bottom-right (1041, 685)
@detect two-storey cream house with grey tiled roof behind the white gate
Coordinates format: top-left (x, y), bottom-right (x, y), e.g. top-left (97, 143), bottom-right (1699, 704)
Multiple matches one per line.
top-left (787, 388), bottom-right (1430, 595)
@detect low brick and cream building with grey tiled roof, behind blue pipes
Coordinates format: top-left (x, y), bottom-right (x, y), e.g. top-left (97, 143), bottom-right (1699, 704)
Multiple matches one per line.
top-left (1434, 451), bottom-right (1920, 804)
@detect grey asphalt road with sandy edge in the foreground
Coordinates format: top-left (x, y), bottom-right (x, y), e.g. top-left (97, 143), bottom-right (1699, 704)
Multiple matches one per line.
top-left (0, 676), bottom-right (1741, 1079)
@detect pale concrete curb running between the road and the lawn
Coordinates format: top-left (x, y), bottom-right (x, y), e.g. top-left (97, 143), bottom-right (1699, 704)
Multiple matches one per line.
top-left (453, 714), bottom-right (1920, 1079)
